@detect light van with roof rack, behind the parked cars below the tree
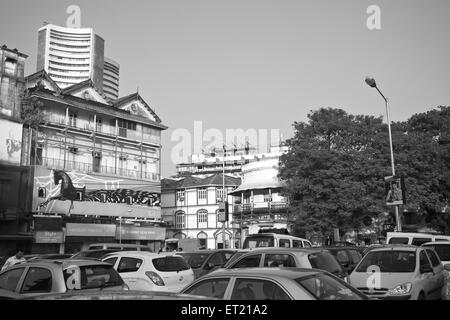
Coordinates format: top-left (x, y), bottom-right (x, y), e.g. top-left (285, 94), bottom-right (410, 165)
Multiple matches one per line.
top-left (242, 233), bottom-right (312, 249)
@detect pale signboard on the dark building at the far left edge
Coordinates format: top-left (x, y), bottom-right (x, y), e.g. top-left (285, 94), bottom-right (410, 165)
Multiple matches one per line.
top-left (0, 119), bottom-right (22, 165)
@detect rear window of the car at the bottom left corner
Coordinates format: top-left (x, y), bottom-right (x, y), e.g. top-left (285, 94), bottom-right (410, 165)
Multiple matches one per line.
top-left (63, 265), bottom-right (123, 290)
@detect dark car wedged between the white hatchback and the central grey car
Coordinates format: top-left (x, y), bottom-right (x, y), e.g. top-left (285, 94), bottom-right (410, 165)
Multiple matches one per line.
top-left (178, 249), bottom-right (236, 278)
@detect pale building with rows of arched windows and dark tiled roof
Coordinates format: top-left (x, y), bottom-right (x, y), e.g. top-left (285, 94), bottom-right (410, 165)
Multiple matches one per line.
top-left (161, 174), bottom-right (240, 249)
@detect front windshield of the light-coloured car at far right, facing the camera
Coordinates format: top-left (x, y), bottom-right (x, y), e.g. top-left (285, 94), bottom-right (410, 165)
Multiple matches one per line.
top-left (356, 250), bottom-right (416, 272)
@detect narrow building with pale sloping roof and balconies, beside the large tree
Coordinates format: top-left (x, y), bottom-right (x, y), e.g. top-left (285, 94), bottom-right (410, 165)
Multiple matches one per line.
top-left (229, 157), bottom-right (293, 245)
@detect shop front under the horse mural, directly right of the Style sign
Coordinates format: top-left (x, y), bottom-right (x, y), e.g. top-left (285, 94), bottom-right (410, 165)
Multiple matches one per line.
top-left (64, 223), bottom-right (116, 253)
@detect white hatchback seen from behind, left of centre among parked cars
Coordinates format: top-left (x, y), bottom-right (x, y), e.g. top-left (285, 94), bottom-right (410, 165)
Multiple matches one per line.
top-left (102, 251), bottom-right (194, 292)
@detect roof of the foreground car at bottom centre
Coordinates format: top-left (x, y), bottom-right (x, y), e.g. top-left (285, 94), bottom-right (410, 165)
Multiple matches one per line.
top-left (202, 267), bottom-right (326, 279)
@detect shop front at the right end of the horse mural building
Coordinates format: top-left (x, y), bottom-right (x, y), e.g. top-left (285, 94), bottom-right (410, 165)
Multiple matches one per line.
top-left (115, 225), bottom-right (166, 252)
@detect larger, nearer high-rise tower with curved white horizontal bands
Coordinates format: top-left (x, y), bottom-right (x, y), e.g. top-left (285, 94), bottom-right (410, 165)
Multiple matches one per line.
top-left (37, 24), bottom-right (105, 90)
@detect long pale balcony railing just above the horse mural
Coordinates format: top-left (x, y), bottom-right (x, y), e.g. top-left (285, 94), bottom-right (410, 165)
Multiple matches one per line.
top-left (37, 158), bottom-right (160, 182)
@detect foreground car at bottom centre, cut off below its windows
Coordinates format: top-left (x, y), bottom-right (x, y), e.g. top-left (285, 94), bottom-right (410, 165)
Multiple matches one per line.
top-left (181, 268), bottom-right (367, 300)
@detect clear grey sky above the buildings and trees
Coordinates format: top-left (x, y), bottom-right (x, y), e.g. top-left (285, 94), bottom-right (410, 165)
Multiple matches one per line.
top-left (0, 0), bottom-right (450, 177)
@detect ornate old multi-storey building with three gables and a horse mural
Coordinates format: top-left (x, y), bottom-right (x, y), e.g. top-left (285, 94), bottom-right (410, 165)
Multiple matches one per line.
top-left (22, 71), bottom-right (167, 252)
